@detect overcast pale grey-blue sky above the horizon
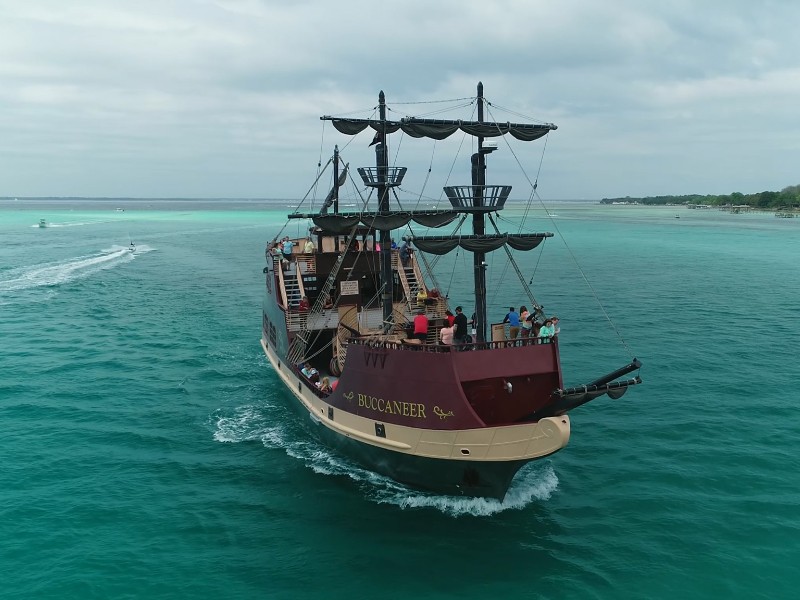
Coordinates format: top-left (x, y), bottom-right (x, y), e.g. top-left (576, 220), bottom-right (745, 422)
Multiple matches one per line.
top-left (0, 0), bottom-right (800, 200)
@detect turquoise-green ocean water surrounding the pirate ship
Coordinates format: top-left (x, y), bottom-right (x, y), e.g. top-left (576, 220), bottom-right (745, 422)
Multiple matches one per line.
top-left (0, 199), bottom-right (800, 600)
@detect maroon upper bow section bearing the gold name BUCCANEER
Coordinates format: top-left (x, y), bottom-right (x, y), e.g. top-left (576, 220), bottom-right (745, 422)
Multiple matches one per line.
top-left (328, 340), bottom-right (561, 430)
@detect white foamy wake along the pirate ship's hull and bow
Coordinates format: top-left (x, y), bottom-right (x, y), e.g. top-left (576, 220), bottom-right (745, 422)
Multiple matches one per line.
top-left (212, 405), bottom-right (558, 517)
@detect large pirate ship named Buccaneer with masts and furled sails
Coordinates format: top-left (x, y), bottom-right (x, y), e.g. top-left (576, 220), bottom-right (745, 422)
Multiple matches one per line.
top-left (261, 84), bottom-right (641, 500)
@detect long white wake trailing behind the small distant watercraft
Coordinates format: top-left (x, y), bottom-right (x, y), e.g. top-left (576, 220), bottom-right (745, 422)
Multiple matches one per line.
top-left (0, 246), bottom-right (152, 293)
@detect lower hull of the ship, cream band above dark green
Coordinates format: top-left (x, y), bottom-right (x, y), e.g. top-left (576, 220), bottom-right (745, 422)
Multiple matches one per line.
top-left (261, 339), bottom-right (570, 500)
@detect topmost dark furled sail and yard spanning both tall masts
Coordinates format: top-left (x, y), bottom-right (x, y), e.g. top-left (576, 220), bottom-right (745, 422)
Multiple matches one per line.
top-left (320, 116), bottom-right (558, 142)
